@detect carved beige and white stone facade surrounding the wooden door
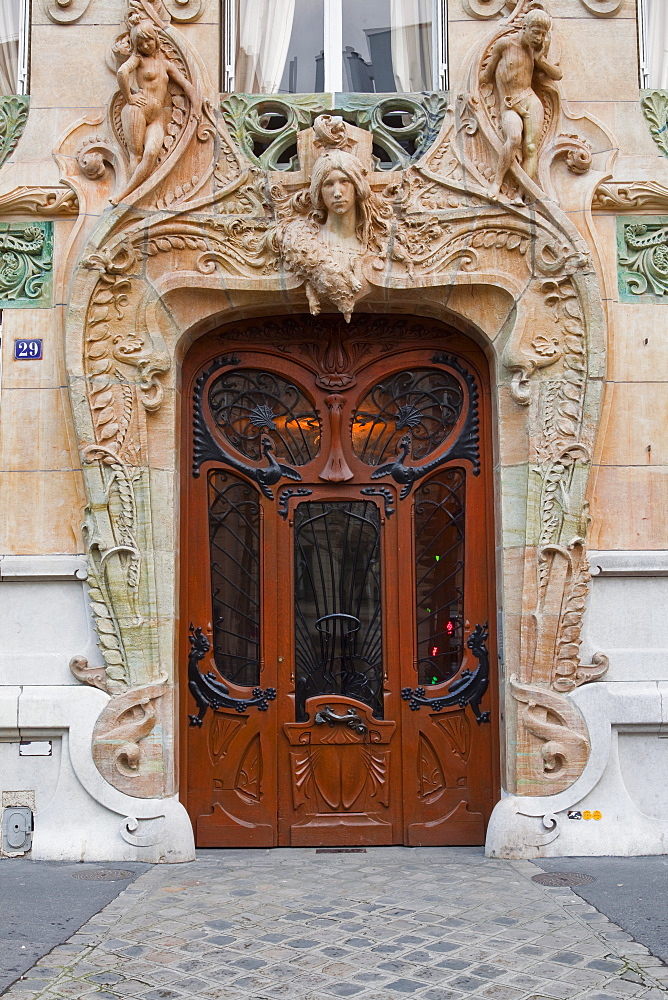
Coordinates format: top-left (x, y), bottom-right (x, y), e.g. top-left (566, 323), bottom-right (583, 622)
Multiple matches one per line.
top-left (0, 0), bottom-right (668, 861)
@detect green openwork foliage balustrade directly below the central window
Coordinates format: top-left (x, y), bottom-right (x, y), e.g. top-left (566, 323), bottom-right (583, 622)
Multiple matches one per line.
top-left (221, 93), bottom-right (447, 170)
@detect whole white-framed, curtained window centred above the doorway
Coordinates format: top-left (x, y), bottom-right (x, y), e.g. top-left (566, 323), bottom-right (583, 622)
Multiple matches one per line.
top-left (223, 0), bottom-right (447, 94)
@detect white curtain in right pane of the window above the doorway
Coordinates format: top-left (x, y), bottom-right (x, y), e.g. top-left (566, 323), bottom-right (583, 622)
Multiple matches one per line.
top-left (390, 0), bottom-right (434, 92)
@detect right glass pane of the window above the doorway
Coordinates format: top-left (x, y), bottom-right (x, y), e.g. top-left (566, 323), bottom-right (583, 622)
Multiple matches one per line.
top-left (342, 0), bottom-right (434, 93)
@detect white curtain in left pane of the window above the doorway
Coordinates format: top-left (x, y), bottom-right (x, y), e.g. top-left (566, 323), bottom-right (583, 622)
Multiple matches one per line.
top-left (234, 0), bottom-right (295, 94)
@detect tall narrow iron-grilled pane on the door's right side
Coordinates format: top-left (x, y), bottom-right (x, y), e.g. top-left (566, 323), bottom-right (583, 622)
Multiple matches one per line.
top-left (415, 469), bottom-right (466, 685)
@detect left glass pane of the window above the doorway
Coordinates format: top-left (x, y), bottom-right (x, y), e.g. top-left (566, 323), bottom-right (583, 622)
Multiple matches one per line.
top-left (235, 0), bottom-right (324, 94)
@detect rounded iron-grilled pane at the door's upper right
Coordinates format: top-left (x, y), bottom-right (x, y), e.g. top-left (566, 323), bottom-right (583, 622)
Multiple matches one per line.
top-left (352, 368), bottom-right (464, 465)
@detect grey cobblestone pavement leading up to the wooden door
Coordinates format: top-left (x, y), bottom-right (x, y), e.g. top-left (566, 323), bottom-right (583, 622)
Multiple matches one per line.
top-left (4, 847), bottom-right (668, 1000)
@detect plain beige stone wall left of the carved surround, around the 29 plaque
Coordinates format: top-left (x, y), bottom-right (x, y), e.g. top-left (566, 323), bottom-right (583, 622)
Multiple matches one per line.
top-left (0, 0), bottom-right (220, 555)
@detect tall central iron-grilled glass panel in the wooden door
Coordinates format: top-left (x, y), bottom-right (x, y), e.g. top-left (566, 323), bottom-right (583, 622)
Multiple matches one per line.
top-left (294, 501), bottom-right (383, 722)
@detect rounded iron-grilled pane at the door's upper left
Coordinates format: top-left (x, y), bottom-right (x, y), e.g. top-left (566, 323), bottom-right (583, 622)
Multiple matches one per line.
top-left (209, 368), bottom-right (320, 465)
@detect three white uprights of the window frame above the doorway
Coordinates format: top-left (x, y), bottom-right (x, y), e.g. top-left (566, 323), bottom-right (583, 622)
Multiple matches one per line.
top-left (222, 0), bottom-right (448, 94)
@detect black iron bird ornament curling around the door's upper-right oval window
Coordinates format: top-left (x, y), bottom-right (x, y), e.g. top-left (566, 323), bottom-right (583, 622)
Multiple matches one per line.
top-left (371, 352), bottom-right (480, 500)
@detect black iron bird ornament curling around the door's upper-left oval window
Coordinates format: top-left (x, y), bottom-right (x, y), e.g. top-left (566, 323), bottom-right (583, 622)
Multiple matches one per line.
top-left (192, 355), bottom-right (302, 500)
